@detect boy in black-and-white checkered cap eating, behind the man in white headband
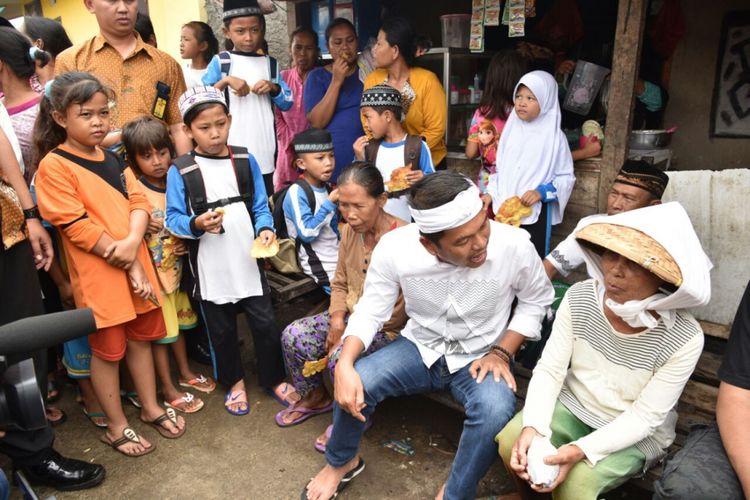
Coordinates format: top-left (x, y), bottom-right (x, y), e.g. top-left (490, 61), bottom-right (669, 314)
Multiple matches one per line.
top-left (354, 84), bottom-right (435, 221)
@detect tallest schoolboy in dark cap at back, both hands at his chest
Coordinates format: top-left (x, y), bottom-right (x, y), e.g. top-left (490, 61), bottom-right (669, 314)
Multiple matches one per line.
top-left (203, 0), bottom-right (294, 193)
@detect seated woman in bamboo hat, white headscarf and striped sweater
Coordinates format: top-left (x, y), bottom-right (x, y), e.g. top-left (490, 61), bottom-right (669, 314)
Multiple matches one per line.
top-left (497, 203), bottom-right (711, 500)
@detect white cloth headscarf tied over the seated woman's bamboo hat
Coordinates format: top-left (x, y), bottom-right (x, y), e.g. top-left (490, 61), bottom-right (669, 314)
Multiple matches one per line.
top-left (576, 202), bottom-right (713, 328)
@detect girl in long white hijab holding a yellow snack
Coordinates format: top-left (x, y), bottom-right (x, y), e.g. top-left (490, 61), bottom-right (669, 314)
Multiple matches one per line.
top-left (488, 71), bottom-right (575, 257)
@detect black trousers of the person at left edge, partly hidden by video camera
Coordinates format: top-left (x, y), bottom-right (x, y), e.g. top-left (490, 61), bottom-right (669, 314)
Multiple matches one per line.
top-left (0, 241), bottom-right (55, 467)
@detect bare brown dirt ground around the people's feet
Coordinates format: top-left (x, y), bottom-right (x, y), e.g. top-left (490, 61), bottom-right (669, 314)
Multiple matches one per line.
top-left (0, 294), bottom-right (652, 499)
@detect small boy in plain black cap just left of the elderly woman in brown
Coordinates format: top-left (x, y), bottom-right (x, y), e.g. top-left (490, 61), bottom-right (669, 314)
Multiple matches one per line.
top-left (273, 128), bottom-right (340, 294)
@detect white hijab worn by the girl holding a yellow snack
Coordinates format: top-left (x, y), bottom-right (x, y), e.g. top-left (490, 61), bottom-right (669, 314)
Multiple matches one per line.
top-left (488, 71), bottom-right (575, 224)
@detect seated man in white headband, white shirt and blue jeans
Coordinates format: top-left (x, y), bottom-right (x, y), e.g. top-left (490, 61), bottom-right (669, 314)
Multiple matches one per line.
top-left (302, 172), bottom-right (554, 500)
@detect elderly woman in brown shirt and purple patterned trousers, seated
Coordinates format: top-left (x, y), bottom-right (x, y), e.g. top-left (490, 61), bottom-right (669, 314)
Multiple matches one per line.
top-left (276, 163), bottom-right (406, 451)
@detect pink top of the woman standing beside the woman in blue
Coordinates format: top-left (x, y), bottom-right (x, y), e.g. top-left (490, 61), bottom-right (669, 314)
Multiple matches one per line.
top-left (273, 68), bottom-right (310, 191)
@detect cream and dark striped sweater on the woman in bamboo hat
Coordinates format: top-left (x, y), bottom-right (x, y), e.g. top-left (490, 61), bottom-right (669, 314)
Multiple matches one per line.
top-left (523, 279), bottom-right (703, 467)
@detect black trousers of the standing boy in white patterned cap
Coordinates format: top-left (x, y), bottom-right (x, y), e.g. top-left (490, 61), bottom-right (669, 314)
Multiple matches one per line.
top-left (201, 292), bottom-right (286, 387)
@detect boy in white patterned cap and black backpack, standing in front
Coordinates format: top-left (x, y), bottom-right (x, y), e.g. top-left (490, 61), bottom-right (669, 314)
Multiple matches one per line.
top-left (166, 87), bottom-right (296, 415)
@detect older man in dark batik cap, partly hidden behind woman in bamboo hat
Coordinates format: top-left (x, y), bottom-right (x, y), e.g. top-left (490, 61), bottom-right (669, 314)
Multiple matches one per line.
top-left (544, 160), bottom-right (669, 279)
